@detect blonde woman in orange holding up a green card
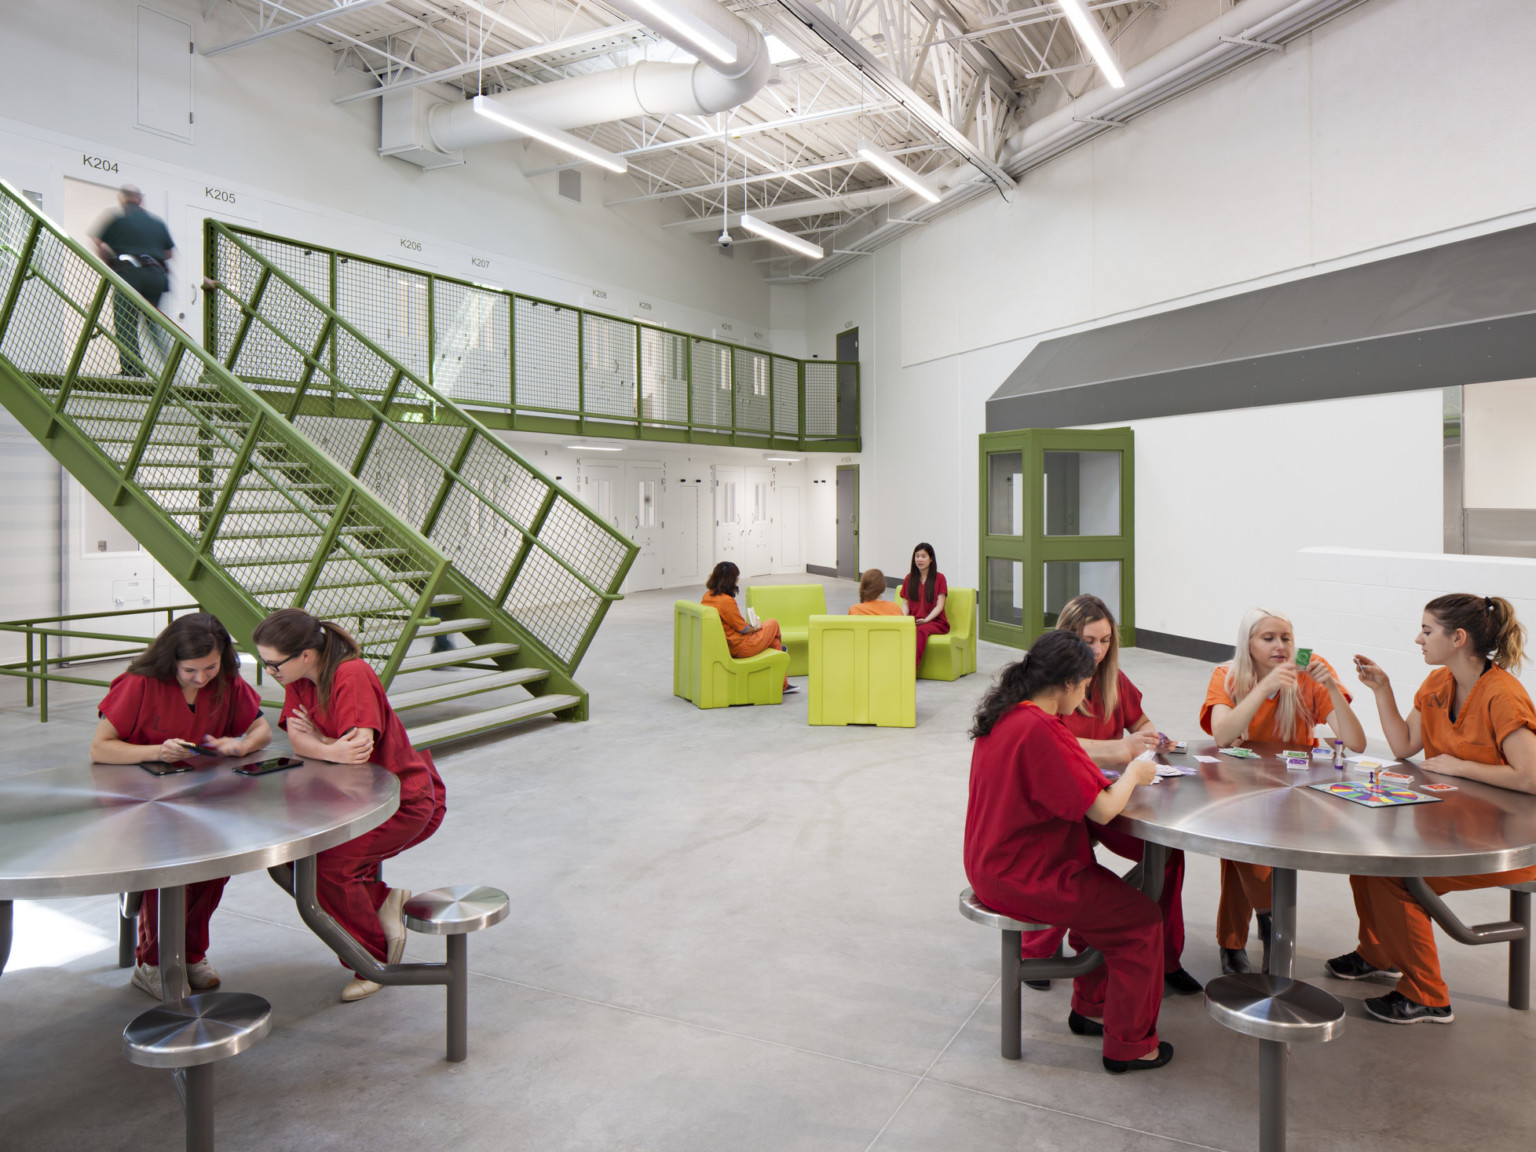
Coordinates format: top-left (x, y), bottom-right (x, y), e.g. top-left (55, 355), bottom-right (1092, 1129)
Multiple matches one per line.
top-left (1200, 608), bottom-right (1366, 974)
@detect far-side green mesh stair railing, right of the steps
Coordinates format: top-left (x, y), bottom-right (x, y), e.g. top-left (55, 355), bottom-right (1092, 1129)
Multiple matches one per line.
top-left (209, 221), bottom-right (639, 671)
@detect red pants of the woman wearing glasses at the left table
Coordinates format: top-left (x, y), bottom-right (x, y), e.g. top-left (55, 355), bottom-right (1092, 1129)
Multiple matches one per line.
top-left (315, 777), bottom-right (447, 975)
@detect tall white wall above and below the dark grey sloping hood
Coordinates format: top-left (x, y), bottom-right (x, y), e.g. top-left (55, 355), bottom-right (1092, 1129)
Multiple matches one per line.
top-left (806, 0), bottom-right (1536, 651)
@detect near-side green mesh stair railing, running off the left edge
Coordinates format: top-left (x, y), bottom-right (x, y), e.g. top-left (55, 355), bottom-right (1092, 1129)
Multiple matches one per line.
top-left (0, 183), bottom-right (449, 684)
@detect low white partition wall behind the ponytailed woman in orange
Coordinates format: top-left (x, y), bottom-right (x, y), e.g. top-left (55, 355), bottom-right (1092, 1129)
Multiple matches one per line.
top-left (1292, 548), bottom-right (1536, 740)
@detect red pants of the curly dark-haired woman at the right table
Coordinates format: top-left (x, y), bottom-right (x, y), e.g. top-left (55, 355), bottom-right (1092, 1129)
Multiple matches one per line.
top-left (972, 863), bottom-right (1163, 1060)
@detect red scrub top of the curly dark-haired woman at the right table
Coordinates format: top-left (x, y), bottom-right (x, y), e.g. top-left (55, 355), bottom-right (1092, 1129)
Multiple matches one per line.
top-left (965, 700), bottom-right (1109, 912)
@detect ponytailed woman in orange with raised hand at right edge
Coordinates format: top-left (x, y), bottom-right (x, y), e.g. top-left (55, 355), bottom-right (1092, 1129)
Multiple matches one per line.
top-left (1327, 593), bottom-right (1536, 1025)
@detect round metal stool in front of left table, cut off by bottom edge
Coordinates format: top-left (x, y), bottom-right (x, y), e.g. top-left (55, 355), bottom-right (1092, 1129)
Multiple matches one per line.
top-left (123, 992), bottom-right (272, 1152)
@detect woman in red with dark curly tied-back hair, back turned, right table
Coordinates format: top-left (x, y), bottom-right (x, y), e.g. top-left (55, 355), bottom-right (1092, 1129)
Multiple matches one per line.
top-left (965, 631), bottom-right (1174, 1072)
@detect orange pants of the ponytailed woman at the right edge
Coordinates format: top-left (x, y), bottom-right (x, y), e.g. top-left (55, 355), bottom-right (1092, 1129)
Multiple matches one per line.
top-left (1349, 868), bottom-right (1536, 1008)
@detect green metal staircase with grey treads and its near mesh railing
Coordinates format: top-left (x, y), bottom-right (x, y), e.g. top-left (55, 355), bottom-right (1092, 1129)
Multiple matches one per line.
top-left (0, 183), bottom-right (633, 745)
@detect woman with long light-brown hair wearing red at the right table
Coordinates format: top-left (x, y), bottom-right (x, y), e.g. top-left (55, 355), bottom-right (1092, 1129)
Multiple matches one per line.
top-left (1021, 594), bottom-right (1201, 995)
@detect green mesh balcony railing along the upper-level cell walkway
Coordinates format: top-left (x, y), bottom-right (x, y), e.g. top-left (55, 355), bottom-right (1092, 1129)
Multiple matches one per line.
top-left (204, 220), bottom-right (859, 452)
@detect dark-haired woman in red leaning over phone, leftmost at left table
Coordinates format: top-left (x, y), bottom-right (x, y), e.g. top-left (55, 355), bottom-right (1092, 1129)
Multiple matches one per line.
top-left (91, 611), bottom-right (272, 1000)
